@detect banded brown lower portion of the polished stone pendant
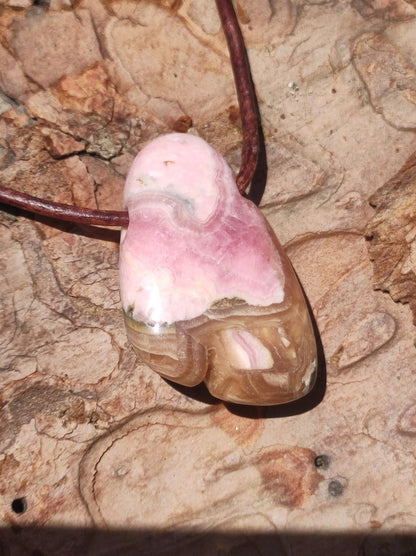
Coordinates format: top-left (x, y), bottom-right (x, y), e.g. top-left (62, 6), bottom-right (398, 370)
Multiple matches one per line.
top-left (125, 282), bottom-right (317, 405)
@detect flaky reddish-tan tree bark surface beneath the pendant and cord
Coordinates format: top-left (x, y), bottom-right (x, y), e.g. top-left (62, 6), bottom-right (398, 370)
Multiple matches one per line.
top-left (0, 0), bottom-right (416, 556)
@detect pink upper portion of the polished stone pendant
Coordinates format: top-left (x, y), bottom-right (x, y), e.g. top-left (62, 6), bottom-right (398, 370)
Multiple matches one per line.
top-left (120, 133), bottom-right (284, 324)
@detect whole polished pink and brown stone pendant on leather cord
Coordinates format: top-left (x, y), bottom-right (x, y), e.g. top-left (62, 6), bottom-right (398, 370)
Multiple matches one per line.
top-left (120, 134), bottom-right (316, 405)
